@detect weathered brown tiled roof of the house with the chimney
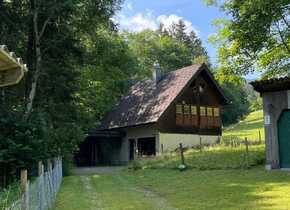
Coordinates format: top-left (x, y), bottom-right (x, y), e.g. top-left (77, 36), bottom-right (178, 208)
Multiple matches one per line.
top-left (99, 64), bottom-right (226, 129)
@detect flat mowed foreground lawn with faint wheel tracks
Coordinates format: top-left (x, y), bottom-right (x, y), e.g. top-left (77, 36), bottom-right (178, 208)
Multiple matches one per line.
top-left (55, 167), bottom-right (290, 210)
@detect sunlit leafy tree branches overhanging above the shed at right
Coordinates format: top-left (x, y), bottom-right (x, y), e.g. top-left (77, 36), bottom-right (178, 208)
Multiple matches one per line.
top-left (206, 0), bottom-right (290, 77)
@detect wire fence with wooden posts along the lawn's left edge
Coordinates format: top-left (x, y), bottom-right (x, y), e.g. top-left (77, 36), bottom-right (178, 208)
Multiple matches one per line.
top-left (4, 158), bottom-right (62, 210)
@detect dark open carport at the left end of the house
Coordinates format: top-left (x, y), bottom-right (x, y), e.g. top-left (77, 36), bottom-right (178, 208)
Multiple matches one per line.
top-left (74, 130), bottom-right (122, 167)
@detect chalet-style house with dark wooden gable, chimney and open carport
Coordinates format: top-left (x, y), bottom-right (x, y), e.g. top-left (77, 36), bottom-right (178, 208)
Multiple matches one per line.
top-left (75, 64), bottom-right (227, 166)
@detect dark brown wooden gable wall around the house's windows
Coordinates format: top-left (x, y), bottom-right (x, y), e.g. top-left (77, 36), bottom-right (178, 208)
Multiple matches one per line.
top-left (158, 72), bottom-right (222, 135)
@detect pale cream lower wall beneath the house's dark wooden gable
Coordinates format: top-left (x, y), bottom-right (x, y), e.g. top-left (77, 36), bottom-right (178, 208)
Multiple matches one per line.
top-left (159, 133), bottom-right (219, 152)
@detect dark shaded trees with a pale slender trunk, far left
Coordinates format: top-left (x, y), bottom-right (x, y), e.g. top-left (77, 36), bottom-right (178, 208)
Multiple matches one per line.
top-left (0, 0), bottom-right (123, 186)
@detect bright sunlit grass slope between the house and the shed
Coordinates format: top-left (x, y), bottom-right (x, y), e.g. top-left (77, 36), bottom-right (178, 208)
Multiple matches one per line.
top-left (223, 110), bottom-right (265, 141)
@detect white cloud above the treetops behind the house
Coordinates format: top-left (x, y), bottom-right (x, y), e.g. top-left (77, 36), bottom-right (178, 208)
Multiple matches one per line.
top-left (113, 9), bottom-right (200, 35)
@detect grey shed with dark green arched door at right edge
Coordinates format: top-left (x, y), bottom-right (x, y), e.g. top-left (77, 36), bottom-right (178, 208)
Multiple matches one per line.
top-left (251, 77), bottom-right (290, 170)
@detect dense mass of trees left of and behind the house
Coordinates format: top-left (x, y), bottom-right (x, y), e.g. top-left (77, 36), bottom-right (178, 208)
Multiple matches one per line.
top-left (0, 0), bottom-right (208, 187)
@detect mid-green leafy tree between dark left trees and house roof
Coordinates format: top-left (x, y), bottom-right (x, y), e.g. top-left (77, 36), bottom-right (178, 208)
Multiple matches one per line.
top-left (76, 28), bottom-right (139, 129)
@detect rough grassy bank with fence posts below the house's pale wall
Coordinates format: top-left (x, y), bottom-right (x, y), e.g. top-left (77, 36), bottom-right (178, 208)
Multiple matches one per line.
top-left (129, 145), bottom-right (265, 170)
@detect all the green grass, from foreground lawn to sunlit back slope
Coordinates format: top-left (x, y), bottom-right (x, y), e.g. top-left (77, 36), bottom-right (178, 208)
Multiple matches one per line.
top-left (55, 111), bottom-right (290, 210)
